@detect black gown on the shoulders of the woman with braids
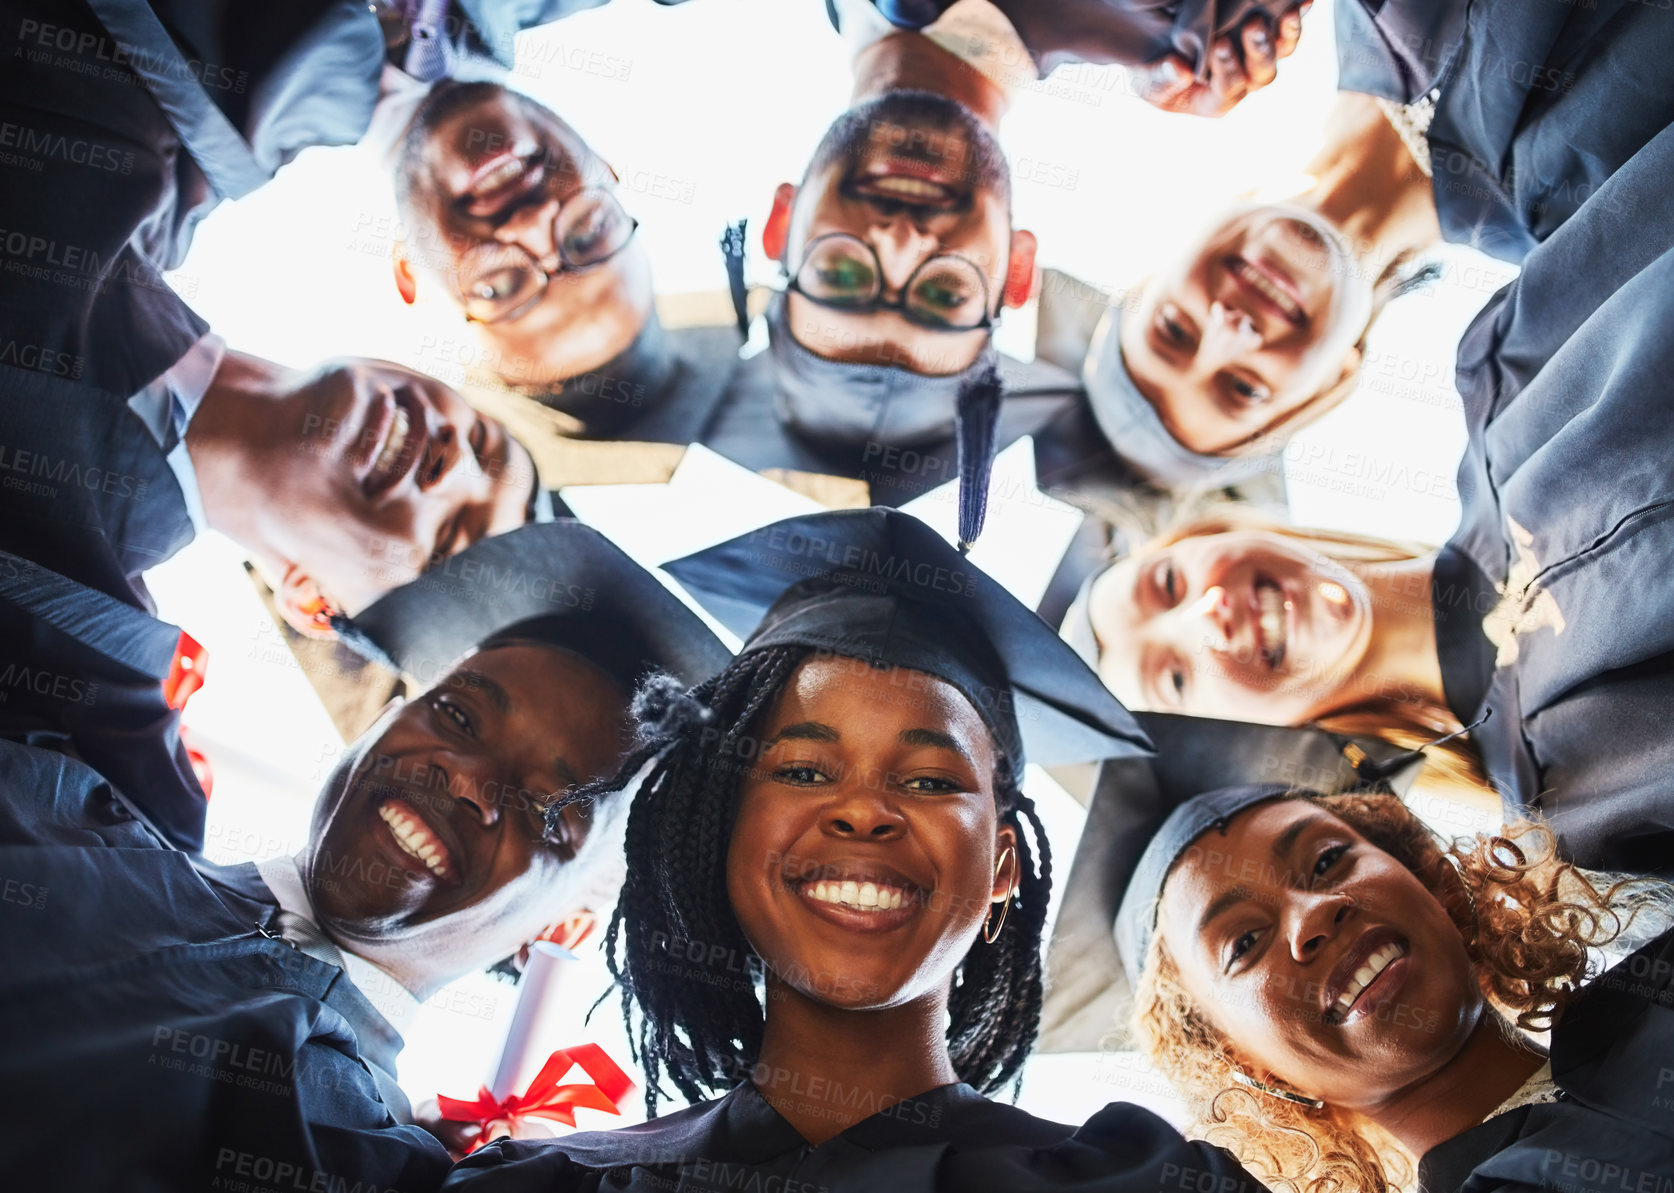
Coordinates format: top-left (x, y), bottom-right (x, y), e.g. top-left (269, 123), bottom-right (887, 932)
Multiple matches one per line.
top-left (444, 1084), bottom-right (1262, 1193)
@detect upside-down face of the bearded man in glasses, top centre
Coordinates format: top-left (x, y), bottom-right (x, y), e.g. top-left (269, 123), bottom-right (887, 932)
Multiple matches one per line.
top-left (775, 92), bottom-right (1011, 375)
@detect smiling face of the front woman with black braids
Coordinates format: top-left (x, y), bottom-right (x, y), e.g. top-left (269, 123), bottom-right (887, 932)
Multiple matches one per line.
top-left (727, 658), bottom-right (1016, 1009)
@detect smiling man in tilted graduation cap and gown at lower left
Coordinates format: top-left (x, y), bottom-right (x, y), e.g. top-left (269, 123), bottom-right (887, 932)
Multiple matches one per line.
top-left (0, 522), bottom-right (727, 1190)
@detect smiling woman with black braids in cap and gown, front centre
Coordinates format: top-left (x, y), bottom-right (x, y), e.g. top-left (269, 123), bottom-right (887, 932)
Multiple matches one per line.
top-left (449, 510), bottom-right (1259, 1193)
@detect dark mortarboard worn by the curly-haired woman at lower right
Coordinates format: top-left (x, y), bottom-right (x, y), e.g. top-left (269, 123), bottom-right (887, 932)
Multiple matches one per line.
top-left (1041, 713), bottom-right (1418, 1052)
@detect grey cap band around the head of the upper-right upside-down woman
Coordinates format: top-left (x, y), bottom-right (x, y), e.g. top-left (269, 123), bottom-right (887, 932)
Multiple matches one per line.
top-left (1081, 306), bottom-right (1282, 489)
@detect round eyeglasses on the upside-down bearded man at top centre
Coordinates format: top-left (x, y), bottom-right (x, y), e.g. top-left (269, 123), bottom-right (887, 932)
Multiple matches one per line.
top-left (785, 233), bottom-right (994, 331)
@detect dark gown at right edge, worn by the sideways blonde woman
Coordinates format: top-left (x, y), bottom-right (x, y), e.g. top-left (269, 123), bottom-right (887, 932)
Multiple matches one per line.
top-left (1433, 129), bottom-right (1674, 877)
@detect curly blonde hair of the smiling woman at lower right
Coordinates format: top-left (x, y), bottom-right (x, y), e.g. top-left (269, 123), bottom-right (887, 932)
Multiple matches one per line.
top-left (1133, 791), bottom-right (1669, 1193)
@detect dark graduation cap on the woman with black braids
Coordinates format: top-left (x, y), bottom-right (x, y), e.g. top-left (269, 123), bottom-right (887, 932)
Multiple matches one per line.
top-left (665, 507), bottom-right (1148, 775)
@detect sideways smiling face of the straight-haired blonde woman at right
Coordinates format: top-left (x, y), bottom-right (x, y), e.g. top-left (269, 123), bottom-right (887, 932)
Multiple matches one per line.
top-left (1088, 530), bottom-right (1373, 725)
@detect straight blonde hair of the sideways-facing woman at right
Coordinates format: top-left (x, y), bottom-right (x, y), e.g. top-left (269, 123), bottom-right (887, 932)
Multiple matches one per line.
top-left (1133, 502), bottom-right (1498, 806)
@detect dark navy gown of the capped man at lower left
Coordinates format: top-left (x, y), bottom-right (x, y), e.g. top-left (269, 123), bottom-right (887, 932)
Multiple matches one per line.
top-left (0, 741), bottom-right (447, 1191)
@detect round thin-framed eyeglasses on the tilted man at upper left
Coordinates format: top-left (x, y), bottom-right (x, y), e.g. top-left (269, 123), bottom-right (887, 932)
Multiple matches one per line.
top-left (459, 187), bottom-right (639, 323)
